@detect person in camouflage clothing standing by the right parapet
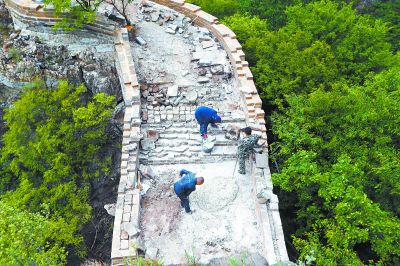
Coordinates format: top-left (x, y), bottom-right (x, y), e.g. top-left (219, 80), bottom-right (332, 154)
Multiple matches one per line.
top-left (238, 127), bottom-right (260, 175)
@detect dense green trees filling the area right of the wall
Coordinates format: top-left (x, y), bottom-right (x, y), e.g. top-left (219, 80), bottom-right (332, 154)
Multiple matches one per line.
top-left (209, 1), bottom-right (400, 265)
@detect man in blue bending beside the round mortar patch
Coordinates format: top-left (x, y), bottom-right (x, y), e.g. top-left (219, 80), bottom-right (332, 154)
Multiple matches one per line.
top-left (174, 169), bottom-right (204, 213)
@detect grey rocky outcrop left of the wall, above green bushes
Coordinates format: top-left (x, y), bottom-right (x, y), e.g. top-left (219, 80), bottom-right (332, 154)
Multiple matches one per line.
top-left (0, 32), bottom-right (122, 101)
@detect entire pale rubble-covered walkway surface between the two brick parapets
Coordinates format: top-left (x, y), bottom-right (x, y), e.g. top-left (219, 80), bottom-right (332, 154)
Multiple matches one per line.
top-left (126, 3), bottom-right (263, 265)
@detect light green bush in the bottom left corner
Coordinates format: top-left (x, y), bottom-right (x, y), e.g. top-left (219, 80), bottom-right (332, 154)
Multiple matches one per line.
top-left (0, 201), bottom-right (66, 265)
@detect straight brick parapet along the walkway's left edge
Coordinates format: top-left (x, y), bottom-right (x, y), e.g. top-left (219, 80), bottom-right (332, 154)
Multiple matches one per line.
top-left (111, 29), bottom-right (142, 265)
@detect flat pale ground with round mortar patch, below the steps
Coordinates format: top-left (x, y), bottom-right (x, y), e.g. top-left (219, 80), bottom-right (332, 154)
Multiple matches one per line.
top-left (141, 161), bottom-right (262, 265)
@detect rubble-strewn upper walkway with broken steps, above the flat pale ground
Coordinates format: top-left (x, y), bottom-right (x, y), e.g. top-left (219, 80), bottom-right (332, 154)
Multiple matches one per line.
top-left (132, 2), bottom-right (250, 164)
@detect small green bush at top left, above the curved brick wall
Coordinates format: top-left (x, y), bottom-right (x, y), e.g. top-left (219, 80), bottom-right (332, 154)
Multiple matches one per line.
top-left (44, 0), bottom-right (102, 31)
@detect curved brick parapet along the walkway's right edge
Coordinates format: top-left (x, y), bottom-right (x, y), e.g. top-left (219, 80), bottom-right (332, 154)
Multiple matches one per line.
top-left (154, 0), bottom-right (289, 265)
